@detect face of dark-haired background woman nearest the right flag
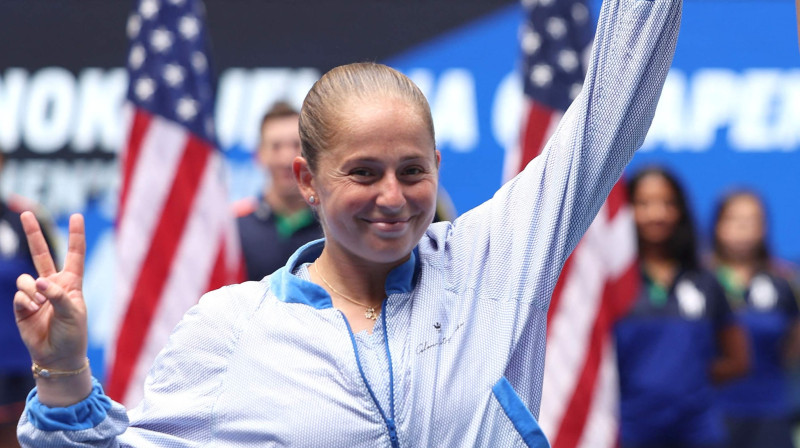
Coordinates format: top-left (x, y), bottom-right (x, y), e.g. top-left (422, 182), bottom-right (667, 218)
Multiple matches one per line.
top-left (632, 174), bottom-right (681, 244)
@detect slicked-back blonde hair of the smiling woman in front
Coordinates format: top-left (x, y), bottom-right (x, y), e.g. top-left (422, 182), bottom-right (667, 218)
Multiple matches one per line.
top-left (300, 62), bottom-right (435, 171)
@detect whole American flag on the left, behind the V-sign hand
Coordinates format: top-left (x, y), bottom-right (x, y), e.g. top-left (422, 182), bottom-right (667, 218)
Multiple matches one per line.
top-left (106, 0), bottom-right (243, 406)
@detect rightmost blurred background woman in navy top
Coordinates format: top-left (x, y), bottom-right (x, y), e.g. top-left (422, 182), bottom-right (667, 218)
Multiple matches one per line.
top-left (713, 191), bottom-right (800, 448)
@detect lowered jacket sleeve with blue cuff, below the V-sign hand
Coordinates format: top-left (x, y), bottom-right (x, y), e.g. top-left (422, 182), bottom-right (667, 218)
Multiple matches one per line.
top-left (17, 282), bottom-right (264, 448)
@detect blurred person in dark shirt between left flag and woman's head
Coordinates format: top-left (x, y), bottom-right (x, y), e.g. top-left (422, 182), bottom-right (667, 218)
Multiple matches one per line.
top-left (236, 102), bottom-right (322, 281)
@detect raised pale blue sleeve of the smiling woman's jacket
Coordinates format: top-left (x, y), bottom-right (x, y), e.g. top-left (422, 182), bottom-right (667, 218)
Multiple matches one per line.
top-left (438, 0), bottom-right (682, 309)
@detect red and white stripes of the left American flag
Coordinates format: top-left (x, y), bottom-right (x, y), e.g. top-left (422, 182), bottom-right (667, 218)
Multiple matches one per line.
top-left (106, 110), bottom-right (241, 406)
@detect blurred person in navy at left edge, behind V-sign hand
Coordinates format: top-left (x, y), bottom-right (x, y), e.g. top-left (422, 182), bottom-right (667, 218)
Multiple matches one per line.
top-left (0, 152), bottom-right (53, 448)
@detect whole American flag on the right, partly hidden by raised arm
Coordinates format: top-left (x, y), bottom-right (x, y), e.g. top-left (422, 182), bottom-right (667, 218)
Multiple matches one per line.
top-left (505, 0), bottom-right (638, 448)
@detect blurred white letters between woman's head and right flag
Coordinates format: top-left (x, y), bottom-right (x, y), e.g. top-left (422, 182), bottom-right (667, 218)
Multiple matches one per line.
top-left (408, 68), bottom-right (480, 152)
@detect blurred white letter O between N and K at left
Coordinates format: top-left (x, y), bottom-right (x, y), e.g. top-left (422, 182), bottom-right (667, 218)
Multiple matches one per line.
top-left (22, 67), bottom-right (75, 154)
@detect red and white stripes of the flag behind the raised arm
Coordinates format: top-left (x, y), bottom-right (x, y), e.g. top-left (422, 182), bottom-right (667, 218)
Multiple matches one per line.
top-left (506, 100), bottom-right (638, 448)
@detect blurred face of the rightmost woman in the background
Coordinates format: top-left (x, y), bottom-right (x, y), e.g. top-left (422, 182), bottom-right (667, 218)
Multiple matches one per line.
top-left (716, 195), bottom-right (765, 259)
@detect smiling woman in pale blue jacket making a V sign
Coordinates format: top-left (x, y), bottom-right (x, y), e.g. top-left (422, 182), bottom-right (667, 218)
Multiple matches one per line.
top-left (15, 0), bottom-right (681, 448)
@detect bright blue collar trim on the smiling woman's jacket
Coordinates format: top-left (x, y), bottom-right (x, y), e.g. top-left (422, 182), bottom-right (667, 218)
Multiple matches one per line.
top-left (269, 238), bottom-right (419, 310)
